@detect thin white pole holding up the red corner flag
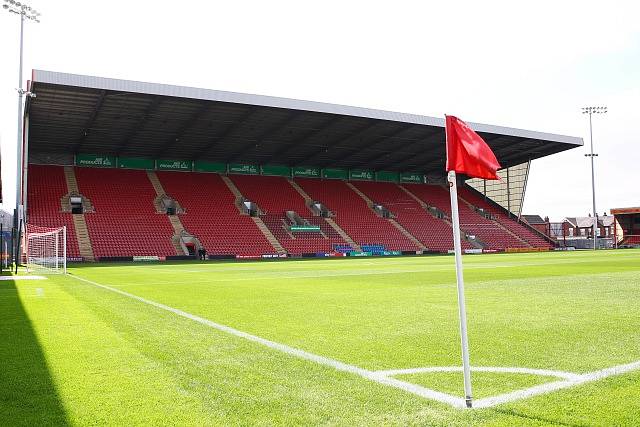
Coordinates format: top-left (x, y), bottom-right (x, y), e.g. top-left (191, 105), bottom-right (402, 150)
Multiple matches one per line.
top-left (445, 118), bottom-right (472, 408)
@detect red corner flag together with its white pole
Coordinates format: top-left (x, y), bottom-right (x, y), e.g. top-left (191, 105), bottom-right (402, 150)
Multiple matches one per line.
top-left (445, 116), bottom-right (500, 408)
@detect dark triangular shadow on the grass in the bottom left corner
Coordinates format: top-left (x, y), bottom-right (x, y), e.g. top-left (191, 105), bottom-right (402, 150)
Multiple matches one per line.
top-left (0, 280), bottom-right (69, 426)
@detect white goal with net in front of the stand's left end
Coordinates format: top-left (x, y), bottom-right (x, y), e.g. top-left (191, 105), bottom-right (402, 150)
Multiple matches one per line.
top-left (25, 224), bottom-right (67, 274)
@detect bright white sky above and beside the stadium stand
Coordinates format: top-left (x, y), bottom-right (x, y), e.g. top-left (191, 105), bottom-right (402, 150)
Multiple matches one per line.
top-left (0, 0), bottom-right (640, 219)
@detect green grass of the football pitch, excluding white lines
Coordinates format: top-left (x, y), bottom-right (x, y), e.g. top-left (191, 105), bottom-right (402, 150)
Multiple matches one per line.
top-left (0, 250), bottom-right (640, 425)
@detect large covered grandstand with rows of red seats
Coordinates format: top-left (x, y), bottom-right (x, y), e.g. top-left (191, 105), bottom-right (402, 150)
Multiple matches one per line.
top-left (21, 70), bottom-right (582, 261)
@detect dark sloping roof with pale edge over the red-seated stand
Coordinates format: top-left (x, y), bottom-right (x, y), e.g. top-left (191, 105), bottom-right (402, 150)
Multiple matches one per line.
top-left (25, 70), bottom-right (583, 174)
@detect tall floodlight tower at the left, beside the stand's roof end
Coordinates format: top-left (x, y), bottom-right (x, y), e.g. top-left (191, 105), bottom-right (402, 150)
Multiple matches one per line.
top-left (2, 0), bottom-right (40, 214)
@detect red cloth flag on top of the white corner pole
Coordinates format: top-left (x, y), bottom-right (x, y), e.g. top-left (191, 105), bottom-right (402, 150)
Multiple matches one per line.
top-left (446, 116), bottom-right (501, 179)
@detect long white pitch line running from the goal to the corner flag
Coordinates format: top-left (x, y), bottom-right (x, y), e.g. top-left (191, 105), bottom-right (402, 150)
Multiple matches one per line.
top-left (70, 275), bottom-right (465, 408)
